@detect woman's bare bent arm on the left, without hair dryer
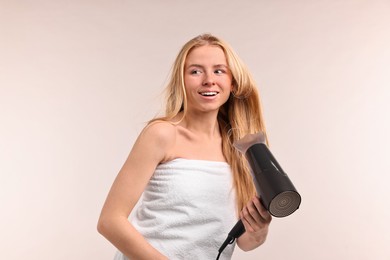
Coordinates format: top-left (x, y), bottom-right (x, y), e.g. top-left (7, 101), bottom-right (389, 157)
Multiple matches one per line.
top-left (97, 122), bottom-right (176, 260)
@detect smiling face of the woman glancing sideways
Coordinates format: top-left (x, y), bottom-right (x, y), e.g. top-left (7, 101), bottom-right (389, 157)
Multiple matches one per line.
top-left (184, 45), bottom-right (232, 112)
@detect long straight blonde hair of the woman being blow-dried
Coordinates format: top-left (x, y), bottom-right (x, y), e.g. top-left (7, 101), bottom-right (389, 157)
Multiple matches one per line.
top-left (151, 34), bottom-right (266, 210)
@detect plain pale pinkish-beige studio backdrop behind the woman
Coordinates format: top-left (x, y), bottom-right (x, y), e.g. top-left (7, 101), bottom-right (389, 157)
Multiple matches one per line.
top-left (0, 0), bottom-right (390, 260)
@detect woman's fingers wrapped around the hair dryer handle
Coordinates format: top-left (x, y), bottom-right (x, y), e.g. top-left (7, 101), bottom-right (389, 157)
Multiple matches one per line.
top-left (240, 197), bottom-right (272, 232)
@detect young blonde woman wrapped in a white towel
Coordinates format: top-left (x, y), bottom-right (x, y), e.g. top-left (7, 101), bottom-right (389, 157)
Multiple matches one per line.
top-left (98, 34), bottom-right (271, 260)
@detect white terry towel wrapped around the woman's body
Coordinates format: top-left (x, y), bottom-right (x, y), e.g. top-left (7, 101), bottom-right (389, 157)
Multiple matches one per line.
top-left (115, 158), bottom-right (237, 260)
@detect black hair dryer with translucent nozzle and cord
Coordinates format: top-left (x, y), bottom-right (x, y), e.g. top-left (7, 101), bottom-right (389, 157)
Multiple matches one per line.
top-left (217, 132), bottom-right (301, 259)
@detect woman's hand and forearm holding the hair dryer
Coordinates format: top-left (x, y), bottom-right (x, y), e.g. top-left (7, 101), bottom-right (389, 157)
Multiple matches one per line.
top-left (237, 197), bottom-right (272, 251)
